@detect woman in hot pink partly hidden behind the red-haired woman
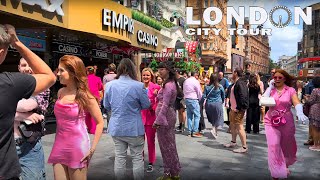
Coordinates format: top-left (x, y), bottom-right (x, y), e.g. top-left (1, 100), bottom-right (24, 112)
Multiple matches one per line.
top-left (86, 66), bottom-right (104, 134)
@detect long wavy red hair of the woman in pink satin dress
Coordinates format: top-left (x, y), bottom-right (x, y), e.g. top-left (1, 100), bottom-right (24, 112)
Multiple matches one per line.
top-left (59, 55), bottom-right (94, 112)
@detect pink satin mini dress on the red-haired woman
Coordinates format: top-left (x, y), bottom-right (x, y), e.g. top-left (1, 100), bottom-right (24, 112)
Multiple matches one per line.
top-left (48, 99), bottom-right (90, 169)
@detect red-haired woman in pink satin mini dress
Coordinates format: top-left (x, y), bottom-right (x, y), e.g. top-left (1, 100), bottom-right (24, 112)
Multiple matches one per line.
top-left (48, 55), bottom-right (103, 180)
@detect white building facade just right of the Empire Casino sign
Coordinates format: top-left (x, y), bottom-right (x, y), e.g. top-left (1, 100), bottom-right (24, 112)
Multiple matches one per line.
top-left (117, 0), bottom-right (189, 74)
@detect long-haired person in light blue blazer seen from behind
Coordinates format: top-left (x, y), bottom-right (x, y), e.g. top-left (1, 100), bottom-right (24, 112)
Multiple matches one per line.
top-left (103, 58), bottom-right (150, 180)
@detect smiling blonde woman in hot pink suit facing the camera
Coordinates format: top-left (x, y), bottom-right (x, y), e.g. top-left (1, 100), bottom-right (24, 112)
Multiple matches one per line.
top-left (141, 68), bottom-right (160, 172)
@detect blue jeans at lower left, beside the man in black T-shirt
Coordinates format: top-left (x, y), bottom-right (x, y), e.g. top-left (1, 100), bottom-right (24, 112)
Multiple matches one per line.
top-left (16, 140), bottom-right (46, 180)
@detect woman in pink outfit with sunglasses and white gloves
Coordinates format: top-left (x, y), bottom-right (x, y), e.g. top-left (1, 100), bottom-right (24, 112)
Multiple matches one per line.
top-left (263, 69), bottom-right (308, 180)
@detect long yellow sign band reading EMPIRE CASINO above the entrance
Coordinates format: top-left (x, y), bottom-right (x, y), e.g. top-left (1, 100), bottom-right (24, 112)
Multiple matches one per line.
top-left (0, 0), bottom-right (162, 52)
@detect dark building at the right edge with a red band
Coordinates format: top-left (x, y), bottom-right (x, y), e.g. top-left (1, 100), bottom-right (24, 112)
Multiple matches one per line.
top-left (298, 3), bottom-right (320, 78)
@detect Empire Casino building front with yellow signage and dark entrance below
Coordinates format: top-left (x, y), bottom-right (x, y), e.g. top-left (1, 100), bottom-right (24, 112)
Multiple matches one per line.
top-left (0, 0), bottom-right (162, 91)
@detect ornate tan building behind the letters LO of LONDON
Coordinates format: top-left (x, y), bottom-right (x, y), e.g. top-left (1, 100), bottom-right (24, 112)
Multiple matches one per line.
top-left (186, 0), bottom-right (229, 72)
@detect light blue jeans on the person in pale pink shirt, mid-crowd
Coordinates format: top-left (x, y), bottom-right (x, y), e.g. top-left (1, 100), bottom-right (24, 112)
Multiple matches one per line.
top-left (186, 99), bottom-right (200, 133)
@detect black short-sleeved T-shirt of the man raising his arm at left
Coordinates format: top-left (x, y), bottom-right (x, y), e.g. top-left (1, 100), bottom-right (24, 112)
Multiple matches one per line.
top-left (0, 72), bottom-right (36, 179)
